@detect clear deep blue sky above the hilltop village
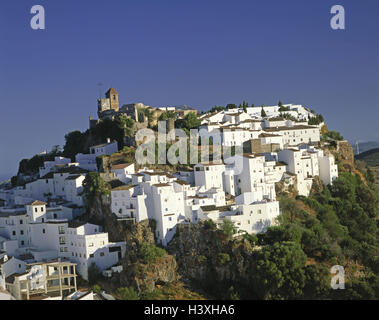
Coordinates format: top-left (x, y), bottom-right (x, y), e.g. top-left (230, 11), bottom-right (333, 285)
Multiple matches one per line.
top-left (0, 0), bottom-right (379, 176)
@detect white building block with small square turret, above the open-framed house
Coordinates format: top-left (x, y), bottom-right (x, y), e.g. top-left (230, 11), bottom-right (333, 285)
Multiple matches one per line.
top-left (0, 201), bottom-right (125, 279)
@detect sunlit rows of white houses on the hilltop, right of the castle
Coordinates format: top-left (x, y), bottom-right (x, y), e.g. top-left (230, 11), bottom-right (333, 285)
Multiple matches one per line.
top-left (199, 104), bottom-right (323, 152)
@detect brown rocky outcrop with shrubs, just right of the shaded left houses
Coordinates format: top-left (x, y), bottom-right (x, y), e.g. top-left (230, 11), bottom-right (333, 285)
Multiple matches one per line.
top-left (83, 196), bottom-right (180, 294)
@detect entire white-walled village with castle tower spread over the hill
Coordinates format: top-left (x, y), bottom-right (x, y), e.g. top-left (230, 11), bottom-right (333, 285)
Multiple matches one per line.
top-left (0, 89), bottom-right (338, 300)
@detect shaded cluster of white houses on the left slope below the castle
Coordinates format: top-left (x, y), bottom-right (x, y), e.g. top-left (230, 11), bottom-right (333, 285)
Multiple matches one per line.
top-left (0, 140), bottom-right (125, 299)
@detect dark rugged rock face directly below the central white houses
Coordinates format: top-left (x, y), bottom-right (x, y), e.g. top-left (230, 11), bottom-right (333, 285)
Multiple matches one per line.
top-left (168, 223), bottom-right (262, 299)
